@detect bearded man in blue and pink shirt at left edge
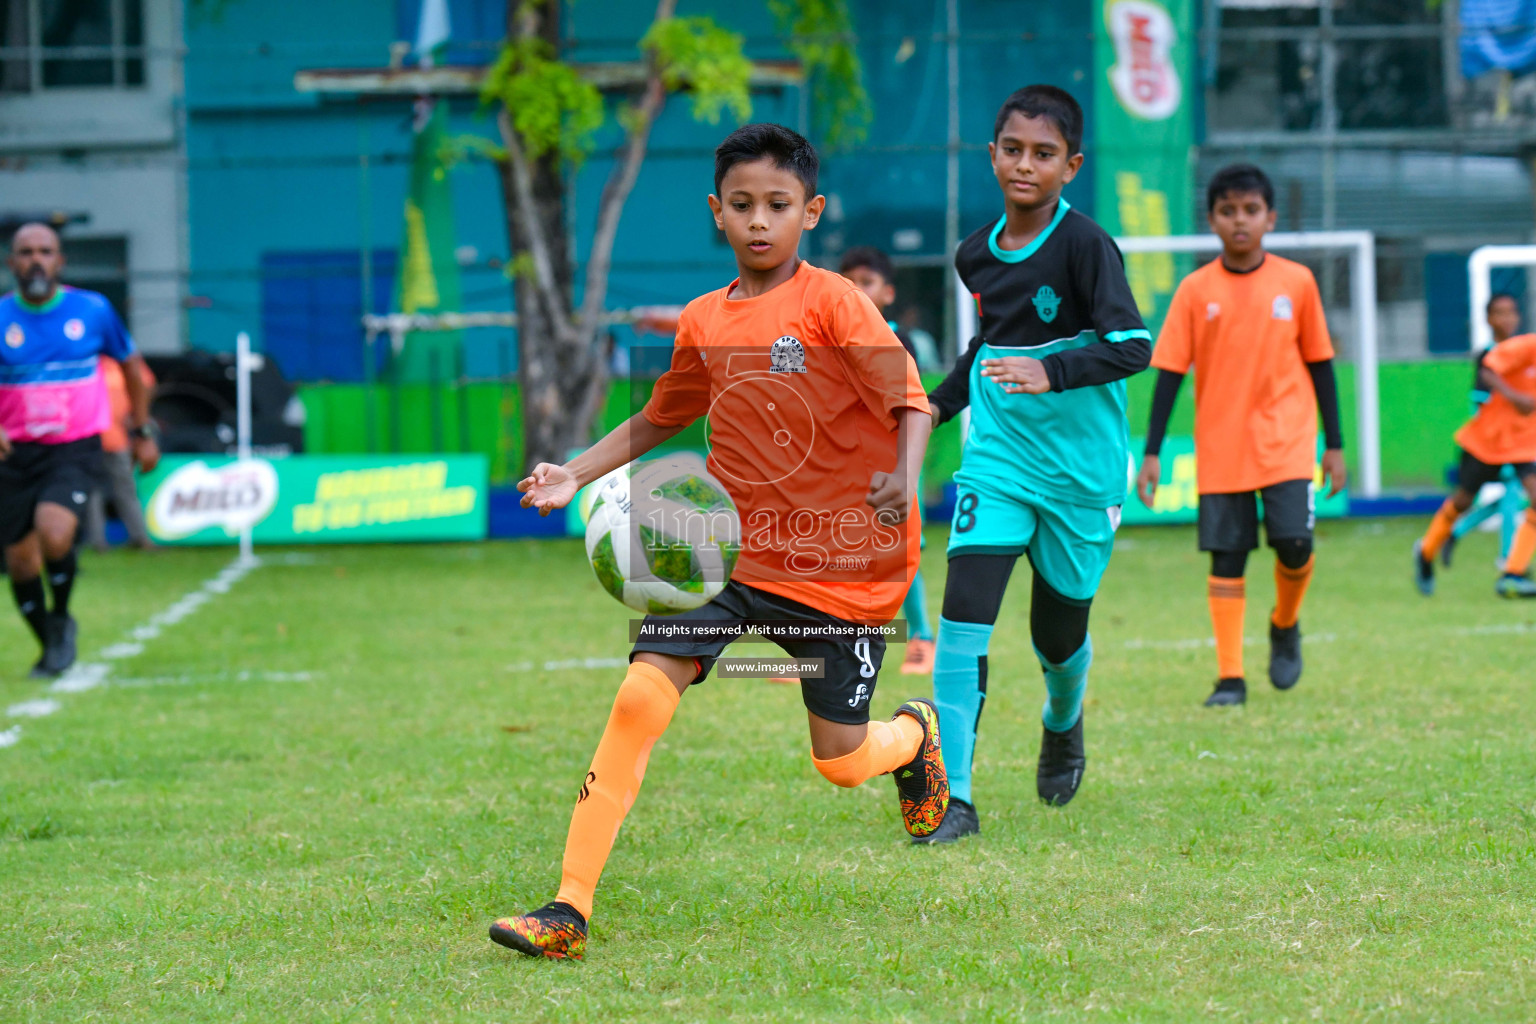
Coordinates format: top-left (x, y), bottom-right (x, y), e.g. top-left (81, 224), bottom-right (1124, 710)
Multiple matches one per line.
top-left (0, 224), bottom-right (160, 679)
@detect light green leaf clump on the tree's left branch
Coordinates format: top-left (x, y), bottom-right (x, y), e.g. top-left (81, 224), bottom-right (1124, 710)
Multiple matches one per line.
top-left (481, 38), bottom-right (604, 163)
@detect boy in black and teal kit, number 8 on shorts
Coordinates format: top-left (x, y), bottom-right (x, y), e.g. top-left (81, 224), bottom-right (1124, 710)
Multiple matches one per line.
top-left (920, 86), bottom-right (1152, 843)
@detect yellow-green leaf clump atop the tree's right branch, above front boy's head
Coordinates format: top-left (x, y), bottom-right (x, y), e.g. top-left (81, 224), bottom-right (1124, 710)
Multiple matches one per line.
top-left (641, 18), bottom-right (753, 124)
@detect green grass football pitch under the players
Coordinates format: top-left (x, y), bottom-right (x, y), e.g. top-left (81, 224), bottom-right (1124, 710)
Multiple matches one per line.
top-left (0, 522), bottom-right (1536, 1022)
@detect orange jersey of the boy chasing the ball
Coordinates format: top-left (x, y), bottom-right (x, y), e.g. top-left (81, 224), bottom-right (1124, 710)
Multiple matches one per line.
top-left (644, 263), bottom-right (928, 622)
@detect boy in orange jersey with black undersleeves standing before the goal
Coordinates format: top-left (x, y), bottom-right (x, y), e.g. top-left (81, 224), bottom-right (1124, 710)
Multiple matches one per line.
top-left (1137, 164), bottom-right (1344, 708)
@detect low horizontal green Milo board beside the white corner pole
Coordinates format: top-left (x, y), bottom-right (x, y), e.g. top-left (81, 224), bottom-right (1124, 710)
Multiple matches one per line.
top-left (138, 454), bottom-right (488, 545)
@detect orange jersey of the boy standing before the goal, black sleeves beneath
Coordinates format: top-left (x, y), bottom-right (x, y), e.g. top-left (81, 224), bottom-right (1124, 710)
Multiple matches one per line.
top-left (1152, 253), bottom-right (1333, 494)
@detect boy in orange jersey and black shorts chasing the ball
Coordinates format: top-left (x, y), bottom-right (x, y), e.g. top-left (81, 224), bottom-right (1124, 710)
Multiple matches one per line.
top-left (490, 124), bottom-right (949, 958)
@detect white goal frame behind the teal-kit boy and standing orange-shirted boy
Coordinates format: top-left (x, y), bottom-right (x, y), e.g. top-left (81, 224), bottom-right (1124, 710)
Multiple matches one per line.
top-left (955, 232), bottom-right (1388, 497)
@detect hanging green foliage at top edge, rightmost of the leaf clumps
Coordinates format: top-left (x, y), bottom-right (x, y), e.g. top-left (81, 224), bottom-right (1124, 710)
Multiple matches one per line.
top-left (768, 0), bottom-right (869, 146)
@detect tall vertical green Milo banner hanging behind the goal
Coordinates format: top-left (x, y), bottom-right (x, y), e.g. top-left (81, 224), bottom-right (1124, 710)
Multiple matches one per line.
top-left (1094, 0), bottom-right (1195, 329)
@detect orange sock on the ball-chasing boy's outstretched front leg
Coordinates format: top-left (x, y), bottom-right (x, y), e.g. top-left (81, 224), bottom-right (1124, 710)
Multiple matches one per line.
top-left (554, 662), bottom-right (680, 920)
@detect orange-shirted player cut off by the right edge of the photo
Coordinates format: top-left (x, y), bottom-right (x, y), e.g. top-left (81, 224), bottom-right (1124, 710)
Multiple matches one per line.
top-left (1413, 295), bottom-right (1536, 597)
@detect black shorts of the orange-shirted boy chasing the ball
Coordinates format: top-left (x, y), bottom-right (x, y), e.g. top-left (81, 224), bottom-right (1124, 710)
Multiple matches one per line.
top-left (630, 580), bottom-right (885, 725)
